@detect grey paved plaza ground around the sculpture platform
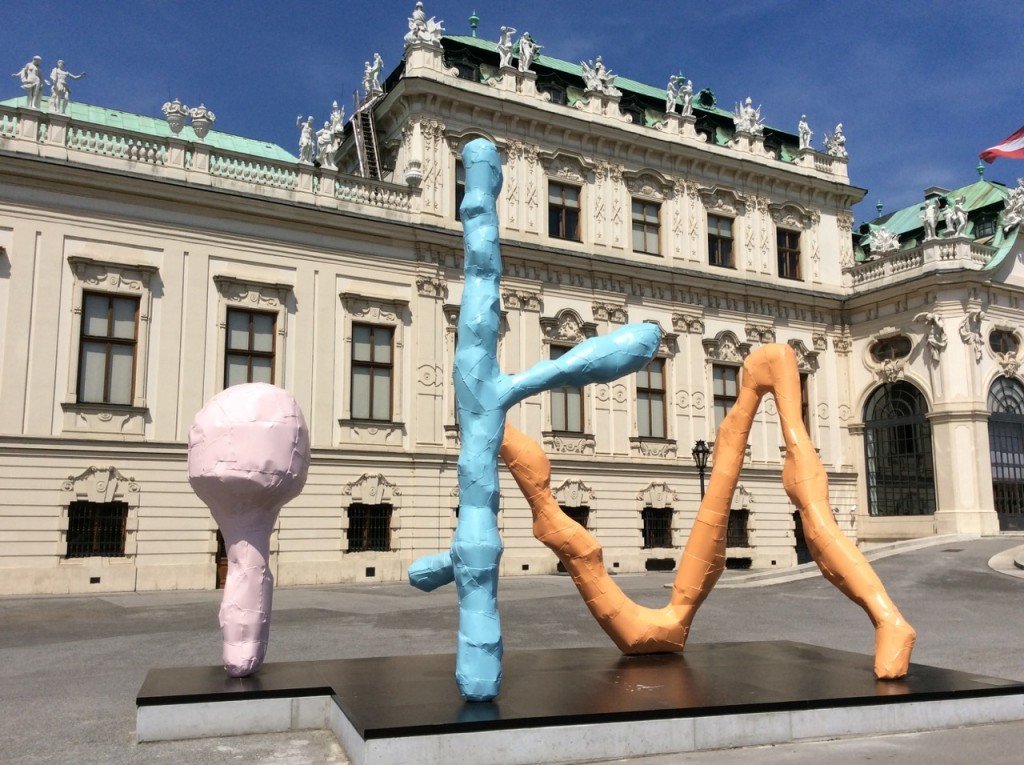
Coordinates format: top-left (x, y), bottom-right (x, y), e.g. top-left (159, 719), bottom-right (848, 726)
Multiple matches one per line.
top-left (0, 537), bottom-right (1024, 765)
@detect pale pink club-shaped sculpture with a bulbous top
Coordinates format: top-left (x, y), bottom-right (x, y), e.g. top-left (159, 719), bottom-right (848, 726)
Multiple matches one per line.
top-left (188, 383), bottom-right (309, 677)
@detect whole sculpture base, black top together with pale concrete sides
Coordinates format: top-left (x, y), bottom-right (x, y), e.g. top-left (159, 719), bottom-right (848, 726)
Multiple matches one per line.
top-left (136, 641), bottom-right (1024, 765)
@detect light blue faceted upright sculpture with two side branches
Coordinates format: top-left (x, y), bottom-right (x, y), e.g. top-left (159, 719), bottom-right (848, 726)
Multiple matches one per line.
top-left (409, 138), bottom-right (662, 702)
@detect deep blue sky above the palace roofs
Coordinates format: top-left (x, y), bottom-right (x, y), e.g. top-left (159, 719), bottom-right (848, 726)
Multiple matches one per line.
top-left (0, 0), bottom-right (1024, 221)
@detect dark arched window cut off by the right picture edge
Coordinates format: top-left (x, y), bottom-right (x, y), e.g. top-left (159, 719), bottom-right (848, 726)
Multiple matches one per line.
top-left (988, 378), bottom-right (1024, 532)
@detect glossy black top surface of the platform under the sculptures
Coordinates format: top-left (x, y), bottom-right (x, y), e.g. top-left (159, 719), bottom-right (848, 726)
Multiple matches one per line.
top-left (136, 641), bottom-right (1024, 740)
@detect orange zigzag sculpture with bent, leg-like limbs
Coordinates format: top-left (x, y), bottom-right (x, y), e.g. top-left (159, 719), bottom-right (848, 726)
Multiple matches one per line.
top-left (501, 344), bottom-right (916, 680)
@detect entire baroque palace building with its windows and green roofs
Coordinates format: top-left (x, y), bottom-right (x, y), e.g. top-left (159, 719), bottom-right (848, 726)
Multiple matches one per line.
top-left (0, 14), bottom-right (1024, 593)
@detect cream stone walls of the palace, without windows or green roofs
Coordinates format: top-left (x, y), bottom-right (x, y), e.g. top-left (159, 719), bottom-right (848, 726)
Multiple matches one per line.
top-left (0, 35), bottom-right (1022, 593)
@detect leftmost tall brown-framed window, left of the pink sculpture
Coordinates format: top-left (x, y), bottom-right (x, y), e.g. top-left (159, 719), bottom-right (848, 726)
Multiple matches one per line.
top-left (78, 292), bottom-right (138, 405)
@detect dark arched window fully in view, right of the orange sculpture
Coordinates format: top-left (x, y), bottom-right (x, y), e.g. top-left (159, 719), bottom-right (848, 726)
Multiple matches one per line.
top-left (864, 381), bottom-right (935, 515)
